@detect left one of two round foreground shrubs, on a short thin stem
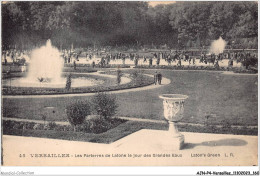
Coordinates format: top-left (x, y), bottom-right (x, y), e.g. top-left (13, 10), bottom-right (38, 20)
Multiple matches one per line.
top-left (66, 101), bottom-right (91, 131)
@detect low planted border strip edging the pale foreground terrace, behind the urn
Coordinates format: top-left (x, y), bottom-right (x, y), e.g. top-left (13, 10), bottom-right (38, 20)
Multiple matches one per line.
top-left (3, 121), bottom-right (258, 144)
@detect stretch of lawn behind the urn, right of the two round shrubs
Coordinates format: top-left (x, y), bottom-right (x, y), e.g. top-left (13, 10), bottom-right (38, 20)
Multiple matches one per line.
top-left (118, 70), bottom-right (258, 125)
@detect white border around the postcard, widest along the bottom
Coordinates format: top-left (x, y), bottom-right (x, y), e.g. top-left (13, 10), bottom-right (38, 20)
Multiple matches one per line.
top-left (0, 0), bottom-right (260, 176)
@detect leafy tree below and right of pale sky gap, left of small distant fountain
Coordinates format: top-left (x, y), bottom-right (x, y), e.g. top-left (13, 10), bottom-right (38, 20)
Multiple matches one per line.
top-left (169, 2), bottom-right (211, 48)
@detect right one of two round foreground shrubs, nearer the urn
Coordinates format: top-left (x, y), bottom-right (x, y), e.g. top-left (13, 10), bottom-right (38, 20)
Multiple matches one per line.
top-left (92, 92), bottom-right (118, 119)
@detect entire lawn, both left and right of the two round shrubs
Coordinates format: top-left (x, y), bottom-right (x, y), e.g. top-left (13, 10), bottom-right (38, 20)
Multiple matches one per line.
top-left (3, 70), bottom-right (258, 126)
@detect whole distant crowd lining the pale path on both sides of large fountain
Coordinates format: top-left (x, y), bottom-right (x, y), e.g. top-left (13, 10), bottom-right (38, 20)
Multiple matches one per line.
top-left (2, 46), bottom-right (257, 67)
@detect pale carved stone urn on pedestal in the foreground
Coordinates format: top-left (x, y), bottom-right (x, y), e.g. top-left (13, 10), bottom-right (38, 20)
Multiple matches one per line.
top-left (159, 94), bottom-right (188, 150)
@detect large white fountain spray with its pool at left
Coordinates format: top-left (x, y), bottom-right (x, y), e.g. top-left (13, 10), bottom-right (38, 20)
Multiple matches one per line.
top-left (3, 39), bottom-right (103, 88)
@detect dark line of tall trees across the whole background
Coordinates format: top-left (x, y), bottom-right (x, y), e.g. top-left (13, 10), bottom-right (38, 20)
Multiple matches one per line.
top-left (2, 1), bottom-right (258, 49)
